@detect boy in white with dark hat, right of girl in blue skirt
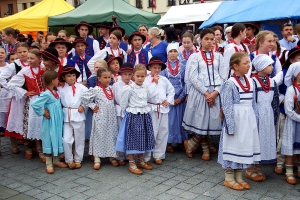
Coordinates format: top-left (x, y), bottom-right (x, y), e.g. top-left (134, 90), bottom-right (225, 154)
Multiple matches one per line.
top-left (145, 56), bottom-right (175, 165)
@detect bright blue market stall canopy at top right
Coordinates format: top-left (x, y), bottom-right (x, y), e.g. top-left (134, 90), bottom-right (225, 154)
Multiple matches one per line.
top-left (199, 0), bottom-right (300, 29)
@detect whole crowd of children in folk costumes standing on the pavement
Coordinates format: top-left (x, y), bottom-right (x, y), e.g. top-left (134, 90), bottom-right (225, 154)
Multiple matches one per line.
top-left (0, 22), bottom-right (300, 190)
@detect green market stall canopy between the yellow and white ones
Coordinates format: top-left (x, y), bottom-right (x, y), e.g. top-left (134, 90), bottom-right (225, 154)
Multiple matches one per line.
top-left (49, 0), bottom-right (160, 34)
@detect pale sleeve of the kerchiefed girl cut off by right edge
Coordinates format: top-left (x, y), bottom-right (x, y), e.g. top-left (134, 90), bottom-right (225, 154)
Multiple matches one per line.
top-left (284, 86), bottom-right (300, 122)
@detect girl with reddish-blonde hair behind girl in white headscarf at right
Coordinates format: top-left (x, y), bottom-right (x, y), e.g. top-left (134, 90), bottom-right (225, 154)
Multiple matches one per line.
top-left (250, 31), bottom-right (282, 78)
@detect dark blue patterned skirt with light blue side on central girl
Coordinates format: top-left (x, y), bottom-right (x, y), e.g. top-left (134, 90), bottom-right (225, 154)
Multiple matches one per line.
top-left (116, 113), bottom-right (155, 154)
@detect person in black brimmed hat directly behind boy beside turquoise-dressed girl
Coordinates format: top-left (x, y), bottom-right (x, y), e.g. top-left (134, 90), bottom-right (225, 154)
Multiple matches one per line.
top-left (49, 38), bottom-right (75, 67)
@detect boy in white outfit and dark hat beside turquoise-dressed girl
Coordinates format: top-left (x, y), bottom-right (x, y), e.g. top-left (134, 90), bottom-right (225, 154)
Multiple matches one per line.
top-left (58, 66), bottom-right (88, 169)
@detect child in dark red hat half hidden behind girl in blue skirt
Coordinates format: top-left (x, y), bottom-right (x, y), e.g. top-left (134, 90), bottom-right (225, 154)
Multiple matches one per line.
top-left (112, 63), bottom-right (133, 165)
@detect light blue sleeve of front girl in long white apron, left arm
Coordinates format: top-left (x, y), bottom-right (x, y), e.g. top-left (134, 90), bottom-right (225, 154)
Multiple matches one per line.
top-left (220, 81), bottom-right (235, 134)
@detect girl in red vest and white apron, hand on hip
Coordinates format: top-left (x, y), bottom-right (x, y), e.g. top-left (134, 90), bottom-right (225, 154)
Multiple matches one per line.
top-left (8, 49), bottom-right (46, 162)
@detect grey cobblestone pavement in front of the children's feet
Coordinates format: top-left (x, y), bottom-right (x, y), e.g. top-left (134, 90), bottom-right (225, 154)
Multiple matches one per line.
top-left (0, 138), bottom-right (300, 200)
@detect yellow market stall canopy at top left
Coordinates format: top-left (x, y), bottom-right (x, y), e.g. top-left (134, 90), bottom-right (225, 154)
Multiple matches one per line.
top-left (0, 0), bottom-right (74, 32)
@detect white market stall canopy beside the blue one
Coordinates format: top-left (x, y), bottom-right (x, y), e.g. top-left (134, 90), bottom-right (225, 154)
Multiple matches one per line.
top-left (157, 2), bottom-right (221, 25)
